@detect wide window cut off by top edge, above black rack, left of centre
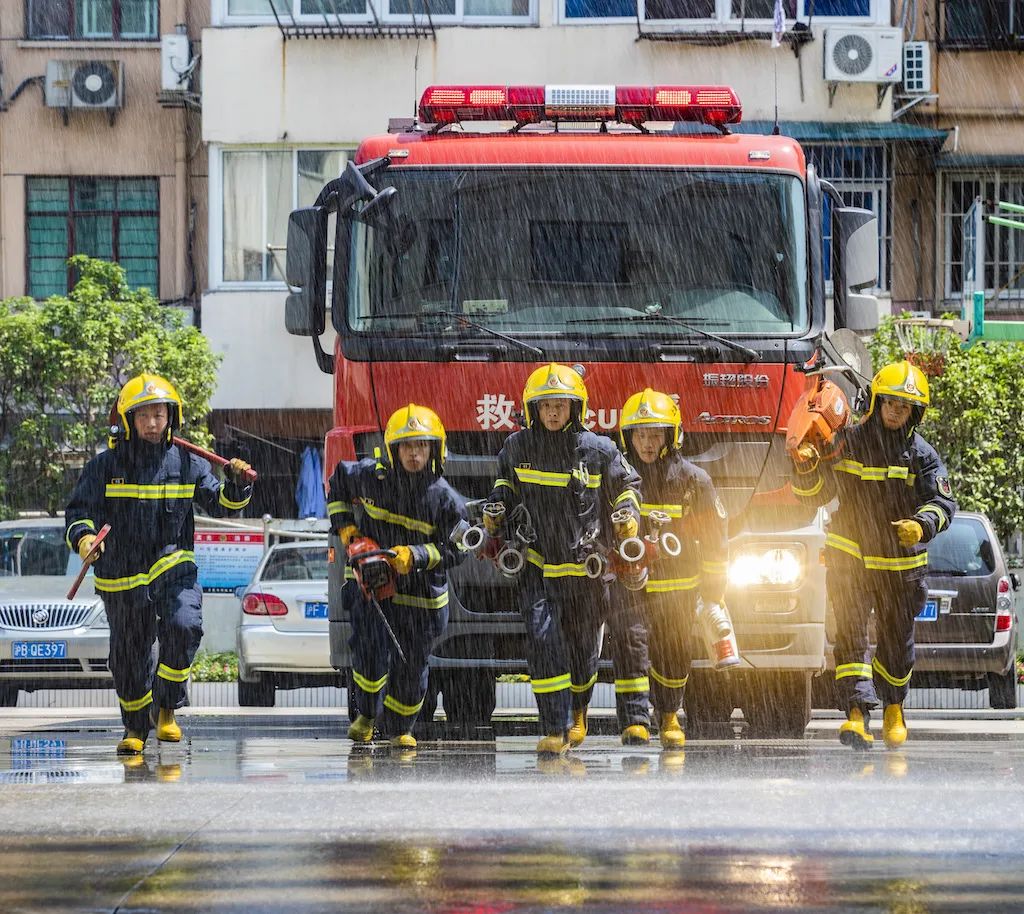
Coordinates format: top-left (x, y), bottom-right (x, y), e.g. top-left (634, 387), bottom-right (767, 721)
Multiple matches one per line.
top-left (222, 0), bottom-right (528, 25)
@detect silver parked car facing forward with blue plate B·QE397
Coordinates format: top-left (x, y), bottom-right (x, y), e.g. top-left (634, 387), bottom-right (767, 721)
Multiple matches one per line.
top-left (0, 518), bottom-right (112, 707)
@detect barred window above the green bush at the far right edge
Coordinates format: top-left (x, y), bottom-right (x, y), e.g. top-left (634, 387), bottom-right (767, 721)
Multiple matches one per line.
top-left (942, 171), bottom-right (1024, 310)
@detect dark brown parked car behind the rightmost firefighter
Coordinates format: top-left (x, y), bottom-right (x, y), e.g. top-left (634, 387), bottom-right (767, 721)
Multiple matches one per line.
top-left (814, 511), bottom-right (1021, 708)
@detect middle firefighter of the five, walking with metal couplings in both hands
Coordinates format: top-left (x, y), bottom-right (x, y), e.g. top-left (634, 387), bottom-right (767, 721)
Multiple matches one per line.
top-left (484, 363), bottom-right (648, 755)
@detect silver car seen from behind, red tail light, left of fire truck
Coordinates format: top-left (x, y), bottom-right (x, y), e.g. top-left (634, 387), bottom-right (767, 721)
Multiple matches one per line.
top-left (237, 541), bottom-right (342, 707)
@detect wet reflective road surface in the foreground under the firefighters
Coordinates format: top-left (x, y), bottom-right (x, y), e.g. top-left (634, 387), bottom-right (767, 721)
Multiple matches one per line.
top-left (0, 709), bottom-right (1024, 914)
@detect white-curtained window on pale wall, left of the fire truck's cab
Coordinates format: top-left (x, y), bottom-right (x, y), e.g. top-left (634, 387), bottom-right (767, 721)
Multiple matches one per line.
top-left (221, 149), bottom-right (349, 282)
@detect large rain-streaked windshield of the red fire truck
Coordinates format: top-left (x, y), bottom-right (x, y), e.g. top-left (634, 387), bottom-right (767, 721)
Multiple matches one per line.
top-left (342, 167), bottom-right (809, 339)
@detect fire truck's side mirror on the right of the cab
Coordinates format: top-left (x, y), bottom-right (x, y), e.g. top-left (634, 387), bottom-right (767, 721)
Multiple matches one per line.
top-left (833, 207), bottom-right (879, 334)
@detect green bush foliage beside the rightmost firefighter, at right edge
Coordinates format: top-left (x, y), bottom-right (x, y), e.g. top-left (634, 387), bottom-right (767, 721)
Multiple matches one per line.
top-left (868, 317), bottom-right (1024, 537)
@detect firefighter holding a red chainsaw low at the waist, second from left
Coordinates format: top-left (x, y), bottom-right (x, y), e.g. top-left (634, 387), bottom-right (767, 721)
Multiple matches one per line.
top-left (328, 403), bottom-right (466, 752)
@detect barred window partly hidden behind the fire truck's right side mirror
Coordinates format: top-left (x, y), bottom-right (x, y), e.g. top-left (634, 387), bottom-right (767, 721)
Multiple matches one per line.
top-left (804, 144), bottom-right (892, 290)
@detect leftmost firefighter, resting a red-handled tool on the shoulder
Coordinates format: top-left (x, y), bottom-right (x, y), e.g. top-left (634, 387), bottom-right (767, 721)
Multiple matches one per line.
top-left (65, 375), bottom-right (252, 755)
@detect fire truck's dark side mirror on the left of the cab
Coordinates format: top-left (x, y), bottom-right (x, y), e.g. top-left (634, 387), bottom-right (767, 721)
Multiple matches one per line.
top-left (285, 207), bottom-right (328, 337)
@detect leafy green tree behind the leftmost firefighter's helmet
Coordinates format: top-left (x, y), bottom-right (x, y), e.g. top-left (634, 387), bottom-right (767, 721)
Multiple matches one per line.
top-left (0, 255), bottom-right (219, 515)
